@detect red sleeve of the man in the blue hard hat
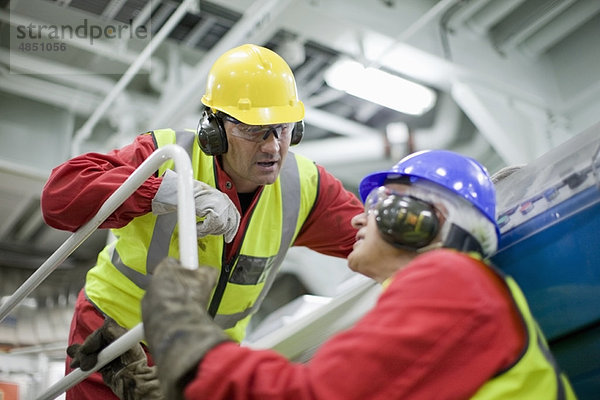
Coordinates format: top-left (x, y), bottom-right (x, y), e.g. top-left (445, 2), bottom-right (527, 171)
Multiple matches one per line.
top-left (185, 250), bottom-right (524, 400)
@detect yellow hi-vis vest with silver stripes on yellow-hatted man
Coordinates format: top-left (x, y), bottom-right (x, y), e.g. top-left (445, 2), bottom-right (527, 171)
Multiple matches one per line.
top-left (85, 129), bottom-right (319, 342)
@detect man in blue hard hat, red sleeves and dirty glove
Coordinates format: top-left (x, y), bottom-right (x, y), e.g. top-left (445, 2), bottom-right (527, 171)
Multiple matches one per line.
top-left (142, 150), bottom-right (575, 400)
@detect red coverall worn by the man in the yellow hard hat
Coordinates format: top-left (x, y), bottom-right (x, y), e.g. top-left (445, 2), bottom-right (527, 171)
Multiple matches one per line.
top-left (41, 135), bottom-right (364, 400)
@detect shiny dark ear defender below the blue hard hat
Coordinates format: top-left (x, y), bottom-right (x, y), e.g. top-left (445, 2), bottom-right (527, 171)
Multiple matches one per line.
top-left (375, 194), bottom-right (440, 251)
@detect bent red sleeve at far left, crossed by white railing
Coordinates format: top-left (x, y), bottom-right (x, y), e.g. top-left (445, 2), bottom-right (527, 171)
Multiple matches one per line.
top-left (41, 134), bottom-right (162, 232)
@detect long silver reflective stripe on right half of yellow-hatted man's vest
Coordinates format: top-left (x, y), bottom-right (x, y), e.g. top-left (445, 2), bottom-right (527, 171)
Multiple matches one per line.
top-left (214, 153), bottom-right (300, 329)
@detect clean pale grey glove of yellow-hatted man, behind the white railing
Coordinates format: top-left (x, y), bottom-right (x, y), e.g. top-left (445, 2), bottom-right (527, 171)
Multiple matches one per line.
top-left (152, 169), bottom-right (240, 243)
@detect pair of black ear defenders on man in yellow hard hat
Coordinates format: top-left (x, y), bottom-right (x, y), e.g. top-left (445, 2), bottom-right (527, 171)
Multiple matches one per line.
top-left (198, 109), bottom-right (304, 156)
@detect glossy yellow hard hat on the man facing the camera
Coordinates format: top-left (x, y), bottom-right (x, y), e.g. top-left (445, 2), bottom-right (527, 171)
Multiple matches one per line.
top-left (202, 44), bottom-right (304, 125)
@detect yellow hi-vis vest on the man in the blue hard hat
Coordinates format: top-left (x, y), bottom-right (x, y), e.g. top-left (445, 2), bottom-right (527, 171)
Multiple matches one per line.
top-left (472, 267), bottom-right (577, 400)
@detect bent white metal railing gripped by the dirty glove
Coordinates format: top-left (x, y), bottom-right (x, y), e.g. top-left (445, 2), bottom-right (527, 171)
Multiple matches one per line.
top-left (0, 144), bottom-right (198, 400)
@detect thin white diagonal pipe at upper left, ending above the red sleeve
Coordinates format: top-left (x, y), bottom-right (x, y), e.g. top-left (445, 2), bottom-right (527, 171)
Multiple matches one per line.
top-left (71, 0), bottom-right (196, 156)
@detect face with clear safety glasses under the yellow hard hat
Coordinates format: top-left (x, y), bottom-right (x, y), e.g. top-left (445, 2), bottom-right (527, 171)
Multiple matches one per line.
top-left (222, 120), bottom-right (294, 193)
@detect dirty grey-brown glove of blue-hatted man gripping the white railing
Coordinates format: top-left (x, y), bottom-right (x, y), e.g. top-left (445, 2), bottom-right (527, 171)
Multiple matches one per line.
top-left (142, 258), bottom-right (231, 399)
